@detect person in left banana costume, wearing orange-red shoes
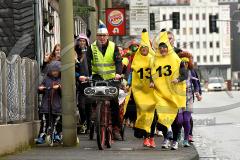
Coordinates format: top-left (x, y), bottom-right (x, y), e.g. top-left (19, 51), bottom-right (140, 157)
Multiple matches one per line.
top-left (128, 29), bottom-right (156, 148)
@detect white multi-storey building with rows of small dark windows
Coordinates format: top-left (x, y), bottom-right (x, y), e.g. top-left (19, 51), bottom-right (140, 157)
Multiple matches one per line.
top-left (150, 0), bottom-right (231, 80)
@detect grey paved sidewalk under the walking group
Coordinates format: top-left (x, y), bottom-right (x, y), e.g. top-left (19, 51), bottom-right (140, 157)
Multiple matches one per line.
top-left (0, 129), bottom-right (198, 160)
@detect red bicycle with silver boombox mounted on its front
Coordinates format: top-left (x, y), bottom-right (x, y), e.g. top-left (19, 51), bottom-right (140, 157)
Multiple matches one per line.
top-left (84, 80), bottom-right (120, 150)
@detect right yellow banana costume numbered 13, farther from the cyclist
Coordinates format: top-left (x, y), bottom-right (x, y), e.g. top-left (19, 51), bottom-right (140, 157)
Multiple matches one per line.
top-left (151, 32), bottom-right (186, 128)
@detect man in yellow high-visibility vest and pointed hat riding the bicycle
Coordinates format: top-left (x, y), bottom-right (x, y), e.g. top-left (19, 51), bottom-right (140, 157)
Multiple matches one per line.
top-left (87, 21), bottom-right (122, 140)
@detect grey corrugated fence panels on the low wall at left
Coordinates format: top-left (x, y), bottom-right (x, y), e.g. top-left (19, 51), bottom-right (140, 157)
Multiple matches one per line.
top-left (0, 52), bottom-right (39, 124)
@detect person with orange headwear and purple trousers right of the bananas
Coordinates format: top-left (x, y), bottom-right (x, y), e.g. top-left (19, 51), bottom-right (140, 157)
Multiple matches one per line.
top-left (172, 51), bottom-right (202, 150)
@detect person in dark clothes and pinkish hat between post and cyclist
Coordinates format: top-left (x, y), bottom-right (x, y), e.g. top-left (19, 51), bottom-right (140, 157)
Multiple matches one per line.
top-left (74, 33), bottom-right (91, 133)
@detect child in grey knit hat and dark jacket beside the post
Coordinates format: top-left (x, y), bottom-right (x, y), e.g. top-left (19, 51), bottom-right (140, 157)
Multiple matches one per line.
top-left (36, 61), bottom-right (62, 144)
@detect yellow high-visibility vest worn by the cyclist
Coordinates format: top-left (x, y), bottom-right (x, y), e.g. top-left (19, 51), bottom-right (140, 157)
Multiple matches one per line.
top-left (91, 41), bottom-right (116, 80)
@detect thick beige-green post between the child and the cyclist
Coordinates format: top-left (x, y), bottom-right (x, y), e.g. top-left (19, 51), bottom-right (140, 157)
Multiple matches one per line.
top-left (59, 0), bottom-right (77, 147)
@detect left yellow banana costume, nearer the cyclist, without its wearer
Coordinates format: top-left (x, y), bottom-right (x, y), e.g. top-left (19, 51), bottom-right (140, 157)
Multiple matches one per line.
top-left (131, 31), bottom-right (156, 132)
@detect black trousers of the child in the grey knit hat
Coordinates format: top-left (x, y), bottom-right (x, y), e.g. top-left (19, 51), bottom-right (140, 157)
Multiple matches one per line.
top-left (39, 113), bottom-right (62, 137)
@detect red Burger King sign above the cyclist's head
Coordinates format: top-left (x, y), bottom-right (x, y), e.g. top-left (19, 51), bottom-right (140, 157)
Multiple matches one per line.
top-left (106, 8), bottom-right (126, 36)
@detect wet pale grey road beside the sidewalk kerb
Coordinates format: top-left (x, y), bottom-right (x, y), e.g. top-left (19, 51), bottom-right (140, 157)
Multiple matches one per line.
top-left (193, 91), bottom-right (240, 160)
